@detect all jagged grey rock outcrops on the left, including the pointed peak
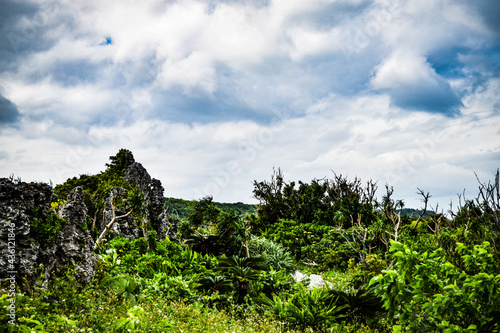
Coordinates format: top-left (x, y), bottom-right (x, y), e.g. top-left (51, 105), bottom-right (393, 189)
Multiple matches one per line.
top-left (0, 153), bottom-right (178, 283)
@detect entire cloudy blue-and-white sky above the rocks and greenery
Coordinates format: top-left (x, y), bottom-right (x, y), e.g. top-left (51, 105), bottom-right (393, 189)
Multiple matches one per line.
top-left (0, 0), bottom-right (500, 211)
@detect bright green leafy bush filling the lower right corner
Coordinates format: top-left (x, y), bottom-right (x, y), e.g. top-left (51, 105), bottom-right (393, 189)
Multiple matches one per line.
top-left (371, 242), bottom-right (500, 332)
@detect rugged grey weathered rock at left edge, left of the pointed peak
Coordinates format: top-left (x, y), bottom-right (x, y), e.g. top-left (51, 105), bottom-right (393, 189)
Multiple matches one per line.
top-left (0, 178), bottom-right (96, 283)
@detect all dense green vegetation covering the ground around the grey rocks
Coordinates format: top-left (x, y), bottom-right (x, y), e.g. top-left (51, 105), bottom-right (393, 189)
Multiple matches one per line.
top-left (0, 155), bottom-right (500, 332)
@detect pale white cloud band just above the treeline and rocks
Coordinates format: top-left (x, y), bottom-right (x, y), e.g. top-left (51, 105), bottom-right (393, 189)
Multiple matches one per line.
top-left (3, 91), bottom-right (500, 207)
